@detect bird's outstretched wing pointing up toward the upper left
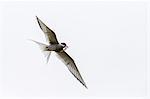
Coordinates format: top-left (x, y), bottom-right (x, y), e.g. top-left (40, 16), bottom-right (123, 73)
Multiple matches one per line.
top-left (36, 16), bottom-right (58, 44)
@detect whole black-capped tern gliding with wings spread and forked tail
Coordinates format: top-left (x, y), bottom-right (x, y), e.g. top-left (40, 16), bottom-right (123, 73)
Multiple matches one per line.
top-left (32, 16), bottom-right (87, 88)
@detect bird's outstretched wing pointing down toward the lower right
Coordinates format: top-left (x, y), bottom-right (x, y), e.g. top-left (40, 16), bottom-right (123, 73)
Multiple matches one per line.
top-left (56, 51), bottom-right (87, 88)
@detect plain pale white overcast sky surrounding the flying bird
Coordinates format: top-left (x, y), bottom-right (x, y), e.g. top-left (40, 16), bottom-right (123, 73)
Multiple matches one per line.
top-left (0, 2), bottom-right (147, 97)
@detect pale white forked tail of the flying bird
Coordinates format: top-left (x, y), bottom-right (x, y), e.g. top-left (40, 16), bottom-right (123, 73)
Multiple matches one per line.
top-left (31, 40), bottom-right (51, 63)
